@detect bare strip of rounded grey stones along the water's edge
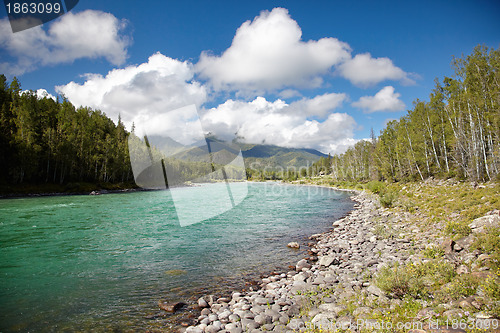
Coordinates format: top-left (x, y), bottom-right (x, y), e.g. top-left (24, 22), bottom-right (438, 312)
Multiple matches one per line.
top-left (178, 192), bottom-right (388, 333)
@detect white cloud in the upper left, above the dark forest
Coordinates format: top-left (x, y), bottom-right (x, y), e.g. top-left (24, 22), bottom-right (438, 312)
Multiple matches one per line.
top-left (0, 10), bottom-right (130, 75)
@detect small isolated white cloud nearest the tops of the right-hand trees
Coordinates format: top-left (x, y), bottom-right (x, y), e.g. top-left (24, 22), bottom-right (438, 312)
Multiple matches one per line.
top-left (352, 86), bottom-right (406, 113)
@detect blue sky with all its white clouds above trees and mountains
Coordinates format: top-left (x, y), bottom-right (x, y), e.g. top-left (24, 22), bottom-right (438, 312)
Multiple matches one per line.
top-left (0, 0), bottom-right (500, 153)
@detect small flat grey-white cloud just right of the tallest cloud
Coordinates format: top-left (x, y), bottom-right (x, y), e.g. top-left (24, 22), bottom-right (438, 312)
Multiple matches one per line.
top-left (338, 53), bottom-right (414, 87)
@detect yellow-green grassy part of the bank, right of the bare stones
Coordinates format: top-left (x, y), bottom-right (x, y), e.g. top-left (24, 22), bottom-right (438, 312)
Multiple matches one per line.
top-left (297, 175), bottom-right (500, 332)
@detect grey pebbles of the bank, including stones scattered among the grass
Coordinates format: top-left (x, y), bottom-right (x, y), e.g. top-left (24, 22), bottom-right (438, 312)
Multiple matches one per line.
top-left (179, 192), bottom-right (490, 333)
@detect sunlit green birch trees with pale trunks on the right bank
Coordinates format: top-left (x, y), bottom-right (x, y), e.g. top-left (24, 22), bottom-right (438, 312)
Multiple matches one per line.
top-left (311, 46), bottom-right (500, 181)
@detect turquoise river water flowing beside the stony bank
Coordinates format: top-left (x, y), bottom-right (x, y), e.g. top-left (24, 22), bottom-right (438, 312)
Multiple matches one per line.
top-left (0, 183), bottom-right (353, 332)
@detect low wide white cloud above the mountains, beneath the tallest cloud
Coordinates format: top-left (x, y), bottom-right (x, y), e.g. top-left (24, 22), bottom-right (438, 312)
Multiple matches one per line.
top-left (201, 97), bottom-right (356, 153)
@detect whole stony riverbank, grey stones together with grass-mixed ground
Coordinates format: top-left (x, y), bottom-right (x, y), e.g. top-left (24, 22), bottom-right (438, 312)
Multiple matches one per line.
top-left (169, 182), bottom-right (500, 333)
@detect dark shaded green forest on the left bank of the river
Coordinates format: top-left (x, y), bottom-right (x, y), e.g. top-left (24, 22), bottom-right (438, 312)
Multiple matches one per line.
top-left (0, 75), bottom-right (133, 185)
